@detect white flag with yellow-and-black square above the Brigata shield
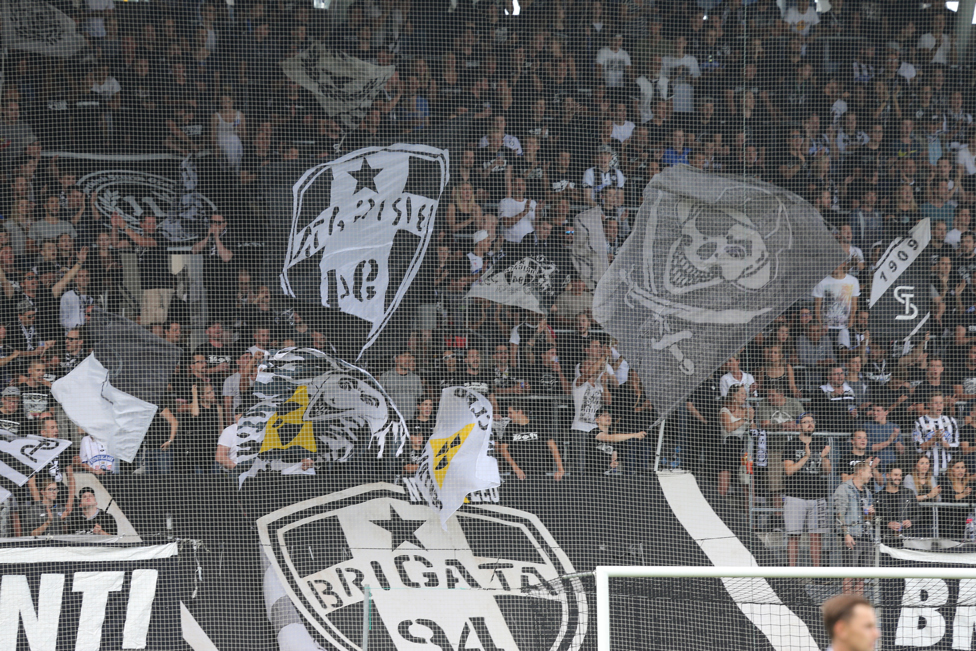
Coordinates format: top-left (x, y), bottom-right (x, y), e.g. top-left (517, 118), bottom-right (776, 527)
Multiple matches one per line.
top-left (416, 387), bottom-right (502, 529)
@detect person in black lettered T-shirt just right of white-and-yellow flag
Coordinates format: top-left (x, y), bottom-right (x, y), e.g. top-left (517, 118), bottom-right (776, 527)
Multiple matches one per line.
top-left (498, 402), bottom-right (566, 481)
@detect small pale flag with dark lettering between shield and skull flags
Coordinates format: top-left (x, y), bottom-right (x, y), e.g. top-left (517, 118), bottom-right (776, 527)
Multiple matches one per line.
top-left (468, 255), bottom-right (559, 314)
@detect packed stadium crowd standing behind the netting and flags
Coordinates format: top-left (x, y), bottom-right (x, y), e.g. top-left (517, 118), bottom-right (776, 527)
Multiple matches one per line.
top-left (0, 0), bottom-right (976, 562)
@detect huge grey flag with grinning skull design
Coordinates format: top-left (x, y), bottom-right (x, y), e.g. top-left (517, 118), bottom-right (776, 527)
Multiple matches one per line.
top-left (593, 165), bottom-right (846, 416)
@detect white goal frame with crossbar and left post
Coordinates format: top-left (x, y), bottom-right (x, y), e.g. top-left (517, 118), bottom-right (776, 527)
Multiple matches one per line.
top-left (593, 564), bottom-right (976, 651)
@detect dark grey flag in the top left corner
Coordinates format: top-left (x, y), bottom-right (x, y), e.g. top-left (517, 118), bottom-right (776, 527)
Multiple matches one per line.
top-left (2, 0), bottom-right (88, 57)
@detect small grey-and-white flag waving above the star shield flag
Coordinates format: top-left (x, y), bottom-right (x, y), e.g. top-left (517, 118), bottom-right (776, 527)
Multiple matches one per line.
top-left (281, 42), bottom-right (396, 131)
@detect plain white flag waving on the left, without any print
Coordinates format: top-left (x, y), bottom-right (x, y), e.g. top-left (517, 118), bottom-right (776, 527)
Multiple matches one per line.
top-left (51, 353), bottom-right (158, 463)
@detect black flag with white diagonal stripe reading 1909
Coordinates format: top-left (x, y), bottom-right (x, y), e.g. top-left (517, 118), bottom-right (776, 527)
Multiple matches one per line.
top-left (868, 219), bottom-right (932, 342)
